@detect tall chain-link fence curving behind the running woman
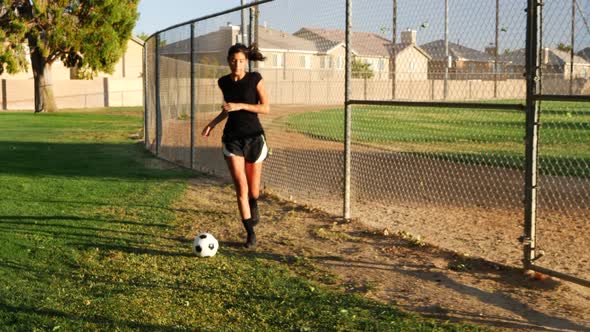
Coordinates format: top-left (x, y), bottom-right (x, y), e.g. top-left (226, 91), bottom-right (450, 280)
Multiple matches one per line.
top-left (145, 0), bottom-right (590, 283)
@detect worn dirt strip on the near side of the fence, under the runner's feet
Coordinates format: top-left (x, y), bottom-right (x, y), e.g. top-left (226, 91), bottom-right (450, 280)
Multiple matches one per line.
top-left (177, 178), bottom-right (590, 331)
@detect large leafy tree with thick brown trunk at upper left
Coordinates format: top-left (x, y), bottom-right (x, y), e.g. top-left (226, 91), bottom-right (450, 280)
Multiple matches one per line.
top-left (0, 0), bottom-right (139, 112)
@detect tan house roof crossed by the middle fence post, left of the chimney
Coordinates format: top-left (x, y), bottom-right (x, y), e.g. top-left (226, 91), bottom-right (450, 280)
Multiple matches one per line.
top-left (294, 28), bottom-right (391, 57)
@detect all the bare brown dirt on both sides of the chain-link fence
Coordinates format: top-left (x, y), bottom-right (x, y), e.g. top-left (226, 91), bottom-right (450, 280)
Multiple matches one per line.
top-left (161, 106), bottom-right (590, 331)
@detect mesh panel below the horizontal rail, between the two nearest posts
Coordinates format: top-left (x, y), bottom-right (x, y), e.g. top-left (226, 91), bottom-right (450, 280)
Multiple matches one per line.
top-left (351, 106), bottom-right (524, 264)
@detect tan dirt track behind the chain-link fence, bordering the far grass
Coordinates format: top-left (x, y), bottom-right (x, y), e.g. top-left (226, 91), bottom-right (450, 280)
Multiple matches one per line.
top-left (161, 105), bottom-right (590, 280)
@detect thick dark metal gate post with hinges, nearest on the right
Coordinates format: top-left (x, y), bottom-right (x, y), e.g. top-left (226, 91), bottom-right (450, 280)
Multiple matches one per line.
top-left (523, 0), bottom-right (539, 268)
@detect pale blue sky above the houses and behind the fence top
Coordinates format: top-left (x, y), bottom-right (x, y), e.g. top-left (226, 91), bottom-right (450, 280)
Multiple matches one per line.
top-left (134, 0), bottom-right (590, 51)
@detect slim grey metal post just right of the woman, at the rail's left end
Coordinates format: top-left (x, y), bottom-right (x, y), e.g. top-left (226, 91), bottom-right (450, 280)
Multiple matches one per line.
top-left (344, 0), bottom-right (352, 220)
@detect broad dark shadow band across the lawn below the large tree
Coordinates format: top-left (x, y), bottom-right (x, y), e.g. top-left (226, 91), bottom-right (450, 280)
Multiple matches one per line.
top-left (0, 141), bottom-right (190, 179)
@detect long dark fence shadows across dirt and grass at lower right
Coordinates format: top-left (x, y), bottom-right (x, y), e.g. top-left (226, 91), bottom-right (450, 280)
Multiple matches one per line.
top-left (231, 239), bottom-right (587, 331)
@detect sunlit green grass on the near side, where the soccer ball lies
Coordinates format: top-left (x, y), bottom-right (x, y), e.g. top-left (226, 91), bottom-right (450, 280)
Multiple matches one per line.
top-left (0, 109), bottom-right (478, 331)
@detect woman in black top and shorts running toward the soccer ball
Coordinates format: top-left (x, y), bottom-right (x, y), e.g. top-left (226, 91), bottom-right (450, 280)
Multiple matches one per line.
top-left (202, 44), bottom-right (270, 248)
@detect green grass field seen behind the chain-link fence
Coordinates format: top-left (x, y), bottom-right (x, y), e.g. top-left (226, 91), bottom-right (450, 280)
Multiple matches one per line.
top-left (287, 102), bottom-right (590, 177)
